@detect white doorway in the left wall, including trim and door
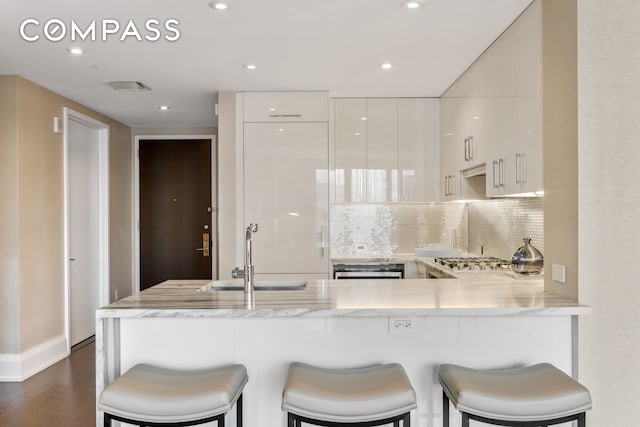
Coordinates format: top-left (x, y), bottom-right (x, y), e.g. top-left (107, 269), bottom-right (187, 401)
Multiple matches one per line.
top-left (63, 108), bottom-right (109, 348)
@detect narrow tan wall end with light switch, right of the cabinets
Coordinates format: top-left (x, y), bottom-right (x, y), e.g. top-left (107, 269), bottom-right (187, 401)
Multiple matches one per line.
top-left (542, 0), bottom-right (578, 298)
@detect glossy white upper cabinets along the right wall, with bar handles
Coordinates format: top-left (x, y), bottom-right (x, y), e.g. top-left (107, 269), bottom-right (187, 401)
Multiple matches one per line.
top-left (440, 1), bottom-right (543, 200)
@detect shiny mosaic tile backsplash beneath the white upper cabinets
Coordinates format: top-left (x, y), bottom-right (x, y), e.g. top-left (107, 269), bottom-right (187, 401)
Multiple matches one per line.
top-left (330, 198), bottom-right (544, 259)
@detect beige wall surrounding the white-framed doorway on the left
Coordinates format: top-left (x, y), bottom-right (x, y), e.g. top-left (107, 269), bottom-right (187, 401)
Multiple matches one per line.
top-left (0, 76), bottom-right (131, 353)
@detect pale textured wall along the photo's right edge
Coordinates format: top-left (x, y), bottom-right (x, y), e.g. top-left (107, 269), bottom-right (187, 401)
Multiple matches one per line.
top-left (578, 0), bottom-right (640, 426)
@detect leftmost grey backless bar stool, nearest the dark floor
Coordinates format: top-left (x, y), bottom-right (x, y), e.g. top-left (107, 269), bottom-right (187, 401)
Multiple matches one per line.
top-left (98, 364), bottom-right (248, 427)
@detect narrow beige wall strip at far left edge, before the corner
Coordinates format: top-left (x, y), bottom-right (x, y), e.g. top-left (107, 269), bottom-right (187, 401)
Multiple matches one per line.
top-left (0, 76), bottom-right (20, 354)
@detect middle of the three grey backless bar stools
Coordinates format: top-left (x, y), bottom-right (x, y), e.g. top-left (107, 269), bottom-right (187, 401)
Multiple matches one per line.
top-left (282, 362), bottom-right (416, 427)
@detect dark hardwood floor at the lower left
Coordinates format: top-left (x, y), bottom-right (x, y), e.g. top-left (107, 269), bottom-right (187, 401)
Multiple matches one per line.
top-left (0, 340), bottom-right (96, 427)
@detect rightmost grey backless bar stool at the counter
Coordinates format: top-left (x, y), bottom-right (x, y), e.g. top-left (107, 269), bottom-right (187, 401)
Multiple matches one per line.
top-left (438, 363), bottom-right (591, 427)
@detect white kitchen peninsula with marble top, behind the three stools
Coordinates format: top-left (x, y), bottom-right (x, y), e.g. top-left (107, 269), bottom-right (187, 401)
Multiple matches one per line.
top-left (96, 280), bottom-right (590, 427)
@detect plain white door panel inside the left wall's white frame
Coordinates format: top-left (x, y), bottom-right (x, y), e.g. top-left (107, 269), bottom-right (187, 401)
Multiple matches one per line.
top-left (68, 120), bottom-right (99, 346)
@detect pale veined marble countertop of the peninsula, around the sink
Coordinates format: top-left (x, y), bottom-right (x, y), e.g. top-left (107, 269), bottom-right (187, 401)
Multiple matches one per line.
top-left (96, 273), bottom-right (591, 318)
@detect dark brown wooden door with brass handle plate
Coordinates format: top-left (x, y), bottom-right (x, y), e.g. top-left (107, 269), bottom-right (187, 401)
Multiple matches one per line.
top-left (139, 139), bottom-right (212, 290)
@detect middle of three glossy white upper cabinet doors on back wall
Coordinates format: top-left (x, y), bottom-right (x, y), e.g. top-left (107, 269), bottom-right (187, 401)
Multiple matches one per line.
top-left (366, 98), bottom-right (398, 202)
